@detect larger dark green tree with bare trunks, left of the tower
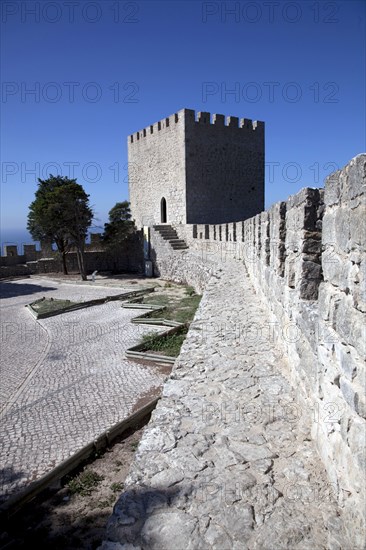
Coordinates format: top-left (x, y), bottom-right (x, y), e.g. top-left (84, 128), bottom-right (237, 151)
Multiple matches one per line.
top-left (27, 174), bottom-right (93, 280)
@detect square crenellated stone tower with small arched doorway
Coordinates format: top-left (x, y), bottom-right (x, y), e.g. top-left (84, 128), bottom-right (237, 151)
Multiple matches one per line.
top-left (128, 109), bottom-right (264, 227)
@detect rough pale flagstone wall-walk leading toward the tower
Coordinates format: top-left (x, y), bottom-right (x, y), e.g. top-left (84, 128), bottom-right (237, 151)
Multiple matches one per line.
top-left (101, 262), bottom-right (346, 550)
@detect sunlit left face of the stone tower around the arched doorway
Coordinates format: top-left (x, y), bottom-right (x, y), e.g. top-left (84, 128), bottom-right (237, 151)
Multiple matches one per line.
top-left (127, 110), bottom-right (186, 228)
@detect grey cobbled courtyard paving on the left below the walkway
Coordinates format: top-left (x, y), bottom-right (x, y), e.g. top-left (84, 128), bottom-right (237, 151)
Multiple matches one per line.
top-left (0, 278), bottom-right (164, 504)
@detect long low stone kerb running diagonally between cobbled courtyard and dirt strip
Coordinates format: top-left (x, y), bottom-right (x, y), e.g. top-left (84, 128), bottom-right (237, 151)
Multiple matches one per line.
top-left (0, 397), bottom-right (160, 519)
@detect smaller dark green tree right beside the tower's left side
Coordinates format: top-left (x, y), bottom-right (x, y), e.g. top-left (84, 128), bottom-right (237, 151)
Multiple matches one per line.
top-left (103, 201), bottom-right (135, 250)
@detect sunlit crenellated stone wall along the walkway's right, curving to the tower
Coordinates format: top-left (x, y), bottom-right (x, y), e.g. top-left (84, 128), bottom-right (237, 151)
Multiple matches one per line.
top-left (151, 154), bottom-right (366, 533)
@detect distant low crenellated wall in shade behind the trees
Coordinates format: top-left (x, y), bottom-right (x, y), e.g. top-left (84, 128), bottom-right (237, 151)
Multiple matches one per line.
top-left (0, 231), bottom-right (144, 278)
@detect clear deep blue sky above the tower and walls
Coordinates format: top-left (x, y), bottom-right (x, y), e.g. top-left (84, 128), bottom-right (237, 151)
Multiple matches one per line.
top-left (1, 0), bottom-right (365, 243)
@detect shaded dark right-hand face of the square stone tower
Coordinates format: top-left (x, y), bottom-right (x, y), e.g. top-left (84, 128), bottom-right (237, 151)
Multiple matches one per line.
top-left (185, 110), bottom-right (264, 224)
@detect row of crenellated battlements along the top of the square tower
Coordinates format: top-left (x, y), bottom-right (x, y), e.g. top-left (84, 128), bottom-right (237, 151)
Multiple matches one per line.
top-left (128, 109), bottom-right (264, 143)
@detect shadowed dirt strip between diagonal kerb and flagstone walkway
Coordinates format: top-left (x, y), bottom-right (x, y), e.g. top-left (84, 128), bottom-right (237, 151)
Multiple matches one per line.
top-left (0, 417), bottom-right (149, 550)
